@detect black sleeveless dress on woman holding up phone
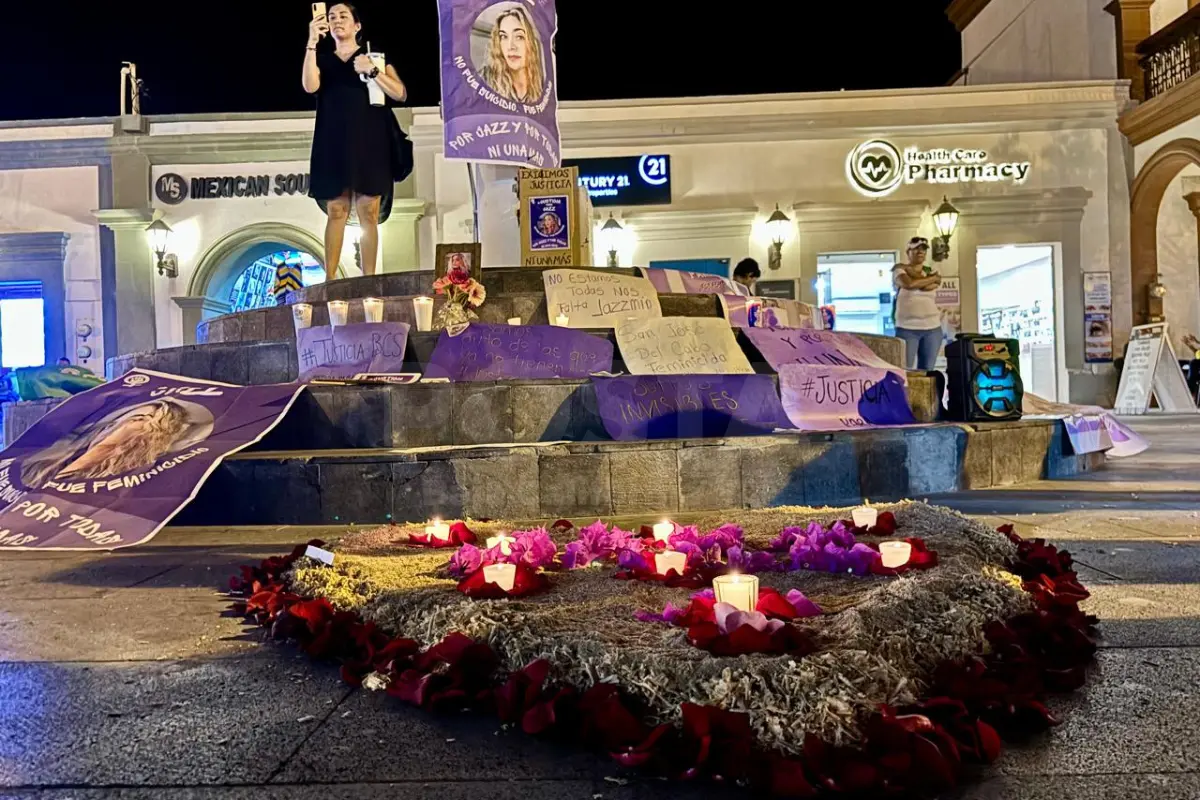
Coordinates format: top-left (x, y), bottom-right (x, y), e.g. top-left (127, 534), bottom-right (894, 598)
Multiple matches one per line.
top-left (308, 47), bottom-right (413, 221)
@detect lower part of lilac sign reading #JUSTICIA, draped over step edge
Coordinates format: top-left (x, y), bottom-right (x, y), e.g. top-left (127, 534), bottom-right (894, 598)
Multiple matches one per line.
top-left (779, 363), bottom-right (917, 431)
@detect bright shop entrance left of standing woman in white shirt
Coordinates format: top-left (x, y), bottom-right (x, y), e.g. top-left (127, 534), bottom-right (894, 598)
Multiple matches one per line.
top-left (816, 251), bottom-right (896, 336)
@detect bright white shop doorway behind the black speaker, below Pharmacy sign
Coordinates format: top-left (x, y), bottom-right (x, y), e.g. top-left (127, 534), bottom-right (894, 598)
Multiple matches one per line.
top-left (976, 245), bottom-right (1064, 401)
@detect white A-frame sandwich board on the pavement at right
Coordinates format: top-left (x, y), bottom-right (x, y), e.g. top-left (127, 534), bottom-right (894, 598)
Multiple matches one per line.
top-left (1114, 323), bottom-right (1200, 414)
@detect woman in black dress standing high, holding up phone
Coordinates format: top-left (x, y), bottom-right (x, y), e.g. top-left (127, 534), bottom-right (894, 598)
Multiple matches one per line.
top-left (304, 2), bottom-right (412, 281)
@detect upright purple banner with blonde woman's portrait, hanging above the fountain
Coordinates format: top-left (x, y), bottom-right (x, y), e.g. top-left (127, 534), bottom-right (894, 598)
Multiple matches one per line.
top-left (438, 0), bottom-right (562, 168)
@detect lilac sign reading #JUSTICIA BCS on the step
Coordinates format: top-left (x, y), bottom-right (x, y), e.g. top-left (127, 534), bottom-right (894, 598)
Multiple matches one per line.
top-left (296, 323), bottom-right (408, 383)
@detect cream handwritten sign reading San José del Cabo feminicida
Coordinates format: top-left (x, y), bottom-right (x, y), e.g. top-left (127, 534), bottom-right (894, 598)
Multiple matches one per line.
top-left (617, 317), bottom-right (754, 375)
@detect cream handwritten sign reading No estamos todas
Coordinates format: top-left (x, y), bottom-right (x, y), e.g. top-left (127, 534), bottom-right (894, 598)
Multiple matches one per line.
top-left (541, 270), bottom-right (662, 327)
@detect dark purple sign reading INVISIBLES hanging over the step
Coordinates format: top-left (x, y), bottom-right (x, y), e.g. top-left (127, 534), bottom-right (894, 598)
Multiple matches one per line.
top-left (592, 375), bottom-right (792, 441)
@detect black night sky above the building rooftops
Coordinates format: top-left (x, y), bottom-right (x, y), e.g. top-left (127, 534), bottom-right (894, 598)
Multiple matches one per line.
top-left (0, 0), bottom-right (960, 120)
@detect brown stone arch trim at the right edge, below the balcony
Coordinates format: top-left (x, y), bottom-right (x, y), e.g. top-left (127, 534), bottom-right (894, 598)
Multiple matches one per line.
top-left (1129, 139), bottom-right (1200, 325)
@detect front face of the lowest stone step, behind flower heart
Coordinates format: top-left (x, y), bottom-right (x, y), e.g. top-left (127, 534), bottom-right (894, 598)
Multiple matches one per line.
top-left (175, 420), bottom-right (1104, 525)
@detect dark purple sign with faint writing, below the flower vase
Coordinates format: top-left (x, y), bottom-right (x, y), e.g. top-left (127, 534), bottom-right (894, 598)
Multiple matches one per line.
top-left (425, 323), bottom-right (612, 383)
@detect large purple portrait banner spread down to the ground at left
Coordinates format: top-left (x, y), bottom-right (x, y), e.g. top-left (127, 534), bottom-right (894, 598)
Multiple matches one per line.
top-left (0, 369), bottom-right (304, 551)
